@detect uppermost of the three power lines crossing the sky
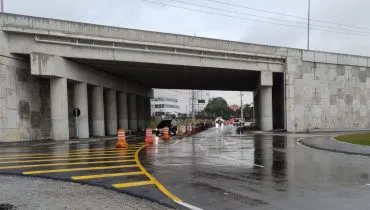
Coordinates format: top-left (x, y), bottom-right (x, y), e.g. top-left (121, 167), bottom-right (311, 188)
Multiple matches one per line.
top-left (206, 0), bottom-right (370, 30)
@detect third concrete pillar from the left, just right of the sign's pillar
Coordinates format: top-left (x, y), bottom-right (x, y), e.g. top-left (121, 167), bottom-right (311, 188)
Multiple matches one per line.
top-left (91, 87), bottom-right (105, 136)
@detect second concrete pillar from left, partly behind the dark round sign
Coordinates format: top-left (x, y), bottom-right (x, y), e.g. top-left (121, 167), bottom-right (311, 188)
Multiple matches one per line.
top-left (73, 83), bottom-right (89, 138)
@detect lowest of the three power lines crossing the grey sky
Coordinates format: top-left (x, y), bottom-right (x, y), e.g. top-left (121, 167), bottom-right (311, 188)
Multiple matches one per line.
top-left (142, 0), bottom-right (369, 36)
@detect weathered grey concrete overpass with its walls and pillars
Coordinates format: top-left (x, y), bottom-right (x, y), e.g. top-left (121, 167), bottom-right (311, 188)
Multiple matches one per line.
top-left (0, 14), bottom-right (370, 141)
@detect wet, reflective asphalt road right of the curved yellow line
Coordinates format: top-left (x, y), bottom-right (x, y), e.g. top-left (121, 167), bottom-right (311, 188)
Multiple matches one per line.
top-left (141, 126), bottom-right (370, 209)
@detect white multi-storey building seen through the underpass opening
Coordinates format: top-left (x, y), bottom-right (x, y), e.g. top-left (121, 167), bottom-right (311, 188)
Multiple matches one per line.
top-left (150, 97), bottom-right (180, 116)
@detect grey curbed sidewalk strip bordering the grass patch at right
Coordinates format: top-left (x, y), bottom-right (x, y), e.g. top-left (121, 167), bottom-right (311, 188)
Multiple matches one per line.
top-left (300, 136), bottom-right (370, 156)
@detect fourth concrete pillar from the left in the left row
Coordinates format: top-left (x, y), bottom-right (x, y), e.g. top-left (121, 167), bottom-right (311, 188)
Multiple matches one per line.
top-left (105, 89), bottom-right (117, 136)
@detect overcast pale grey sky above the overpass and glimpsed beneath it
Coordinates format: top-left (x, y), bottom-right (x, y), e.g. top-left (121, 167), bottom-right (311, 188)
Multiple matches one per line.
top-left (4, 0), bottom-right (370, 110)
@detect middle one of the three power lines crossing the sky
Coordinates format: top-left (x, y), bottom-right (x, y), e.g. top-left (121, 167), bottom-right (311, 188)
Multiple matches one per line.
top-left (164, 0), bottom-right (366, 33)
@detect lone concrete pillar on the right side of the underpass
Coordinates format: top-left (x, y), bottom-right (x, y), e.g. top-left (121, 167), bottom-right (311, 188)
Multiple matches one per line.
top-left (259, 86), bottom-right (272, 131)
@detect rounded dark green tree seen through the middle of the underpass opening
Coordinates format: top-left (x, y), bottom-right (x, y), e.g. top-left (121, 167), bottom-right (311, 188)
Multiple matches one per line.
top-left (204, 97), bottom-right (231, 119)
